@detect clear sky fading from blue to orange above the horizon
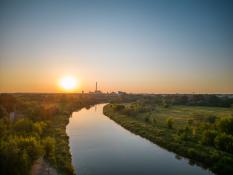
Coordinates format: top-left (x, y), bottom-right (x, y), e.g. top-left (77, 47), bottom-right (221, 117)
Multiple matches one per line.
top-left (0, 0), bottom-right (233, 93)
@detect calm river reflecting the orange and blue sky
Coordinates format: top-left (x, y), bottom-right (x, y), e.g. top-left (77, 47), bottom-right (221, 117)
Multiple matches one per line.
top-left (67, 104), bottom-right (211, 175)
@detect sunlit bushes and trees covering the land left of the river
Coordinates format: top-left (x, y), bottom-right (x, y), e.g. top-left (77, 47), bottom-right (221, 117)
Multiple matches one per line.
top-left (0, 94), bottom-right (112, 175)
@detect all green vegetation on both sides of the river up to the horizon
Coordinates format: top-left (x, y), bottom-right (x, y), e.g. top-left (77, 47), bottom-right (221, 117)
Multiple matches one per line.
top-left (0, 93), bottom-right (233, 175)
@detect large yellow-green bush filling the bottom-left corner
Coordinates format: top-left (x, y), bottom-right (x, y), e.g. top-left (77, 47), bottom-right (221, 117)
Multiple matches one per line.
top-left (0, 137), bottom-right (41, 175)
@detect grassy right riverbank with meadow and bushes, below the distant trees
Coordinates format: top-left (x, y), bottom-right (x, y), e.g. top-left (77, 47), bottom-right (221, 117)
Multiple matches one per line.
top-left (104, 103), bottom-right (233, 174)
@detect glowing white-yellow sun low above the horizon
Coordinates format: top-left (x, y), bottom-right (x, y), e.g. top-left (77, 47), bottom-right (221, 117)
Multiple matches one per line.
top-left (59, 76), bottom-right (78, 91)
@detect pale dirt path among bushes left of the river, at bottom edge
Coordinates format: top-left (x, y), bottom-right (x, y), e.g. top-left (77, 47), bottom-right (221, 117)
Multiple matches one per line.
top-left (31, 158), bottom-right (58, 175)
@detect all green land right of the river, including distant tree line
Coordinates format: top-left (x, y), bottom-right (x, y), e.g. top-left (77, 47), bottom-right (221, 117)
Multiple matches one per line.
top-left (104, 95), bottom-right (233, 174)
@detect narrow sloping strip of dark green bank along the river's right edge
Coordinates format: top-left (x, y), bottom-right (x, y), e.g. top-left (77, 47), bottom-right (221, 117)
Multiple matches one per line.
top-left (103, 104), bottom-right (233, 174)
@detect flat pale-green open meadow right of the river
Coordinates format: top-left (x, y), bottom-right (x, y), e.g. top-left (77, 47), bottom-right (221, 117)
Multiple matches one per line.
top-left (136, 106), bottom-right (233, 129)
